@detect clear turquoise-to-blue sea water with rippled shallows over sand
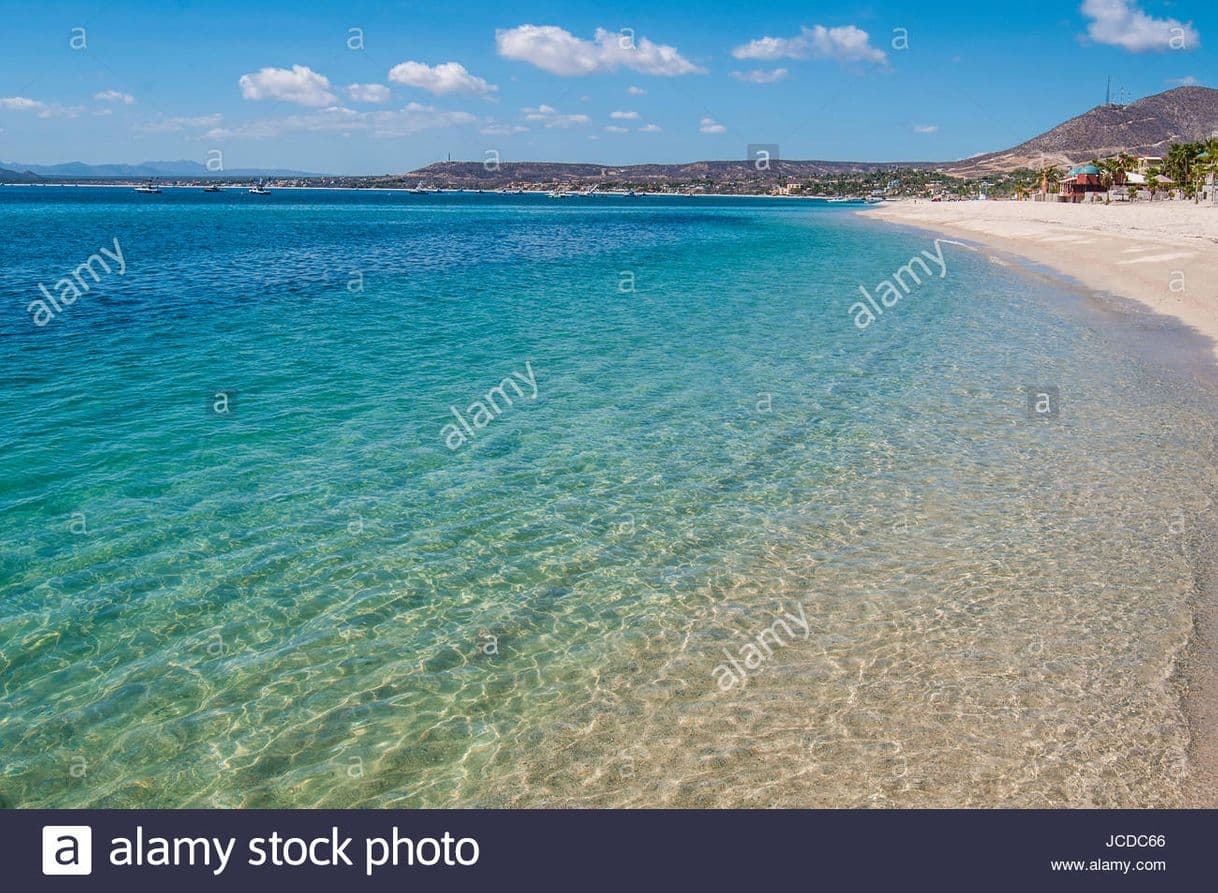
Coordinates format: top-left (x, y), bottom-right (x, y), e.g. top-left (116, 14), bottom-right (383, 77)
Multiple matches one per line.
top-left (0, 188), bottom-right (1216, 807)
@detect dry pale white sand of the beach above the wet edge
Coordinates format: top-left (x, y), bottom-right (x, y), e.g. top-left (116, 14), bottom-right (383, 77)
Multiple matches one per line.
top-left (862, 201), bottom-right (1218, 358)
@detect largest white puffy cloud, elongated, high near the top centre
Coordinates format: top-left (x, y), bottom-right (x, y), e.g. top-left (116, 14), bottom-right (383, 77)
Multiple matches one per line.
top-left (495, 24), bottom-right (704, 77)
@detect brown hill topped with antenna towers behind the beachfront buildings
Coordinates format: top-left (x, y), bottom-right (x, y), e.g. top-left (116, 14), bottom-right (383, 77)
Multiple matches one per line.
top-left (945, 86), bottom-right (1218, 177)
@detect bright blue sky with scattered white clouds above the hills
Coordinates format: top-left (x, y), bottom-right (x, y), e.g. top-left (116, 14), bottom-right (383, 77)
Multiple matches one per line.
top-left (0, 0), bottom-right (1218, 174)
